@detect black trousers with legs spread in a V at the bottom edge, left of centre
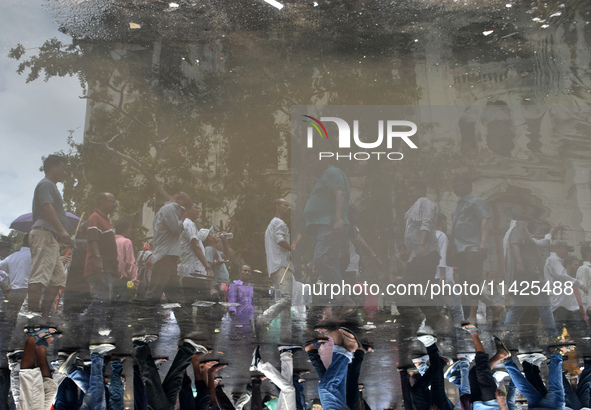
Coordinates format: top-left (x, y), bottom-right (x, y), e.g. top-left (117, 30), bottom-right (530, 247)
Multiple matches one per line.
top-left (133, 341), bottom-right (195, 410)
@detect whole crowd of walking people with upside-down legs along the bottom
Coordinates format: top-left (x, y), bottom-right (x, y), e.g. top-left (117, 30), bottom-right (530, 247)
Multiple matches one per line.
top-left (0, 155), bottom-right (591, 410)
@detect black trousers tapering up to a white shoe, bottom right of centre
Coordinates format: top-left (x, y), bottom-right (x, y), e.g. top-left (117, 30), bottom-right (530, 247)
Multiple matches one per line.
top-left (411, 344), bottom-right (454, 410)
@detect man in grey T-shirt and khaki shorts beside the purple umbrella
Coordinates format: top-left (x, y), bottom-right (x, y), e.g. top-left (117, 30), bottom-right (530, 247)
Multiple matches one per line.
top-left (28, 155), bottom-right (73, 318)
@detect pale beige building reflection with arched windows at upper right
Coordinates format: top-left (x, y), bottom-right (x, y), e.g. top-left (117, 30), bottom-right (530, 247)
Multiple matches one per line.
top-left (416, 16), bottom-right (591, 271)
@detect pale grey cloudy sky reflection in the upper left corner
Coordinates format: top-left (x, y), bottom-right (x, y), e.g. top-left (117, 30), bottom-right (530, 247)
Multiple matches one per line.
top-left (0, 0), bottom-right (86, 234)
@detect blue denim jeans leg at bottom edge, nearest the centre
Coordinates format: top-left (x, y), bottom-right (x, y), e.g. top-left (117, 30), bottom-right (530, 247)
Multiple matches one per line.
top-left (318, 345), bottom-right (353, 410)
